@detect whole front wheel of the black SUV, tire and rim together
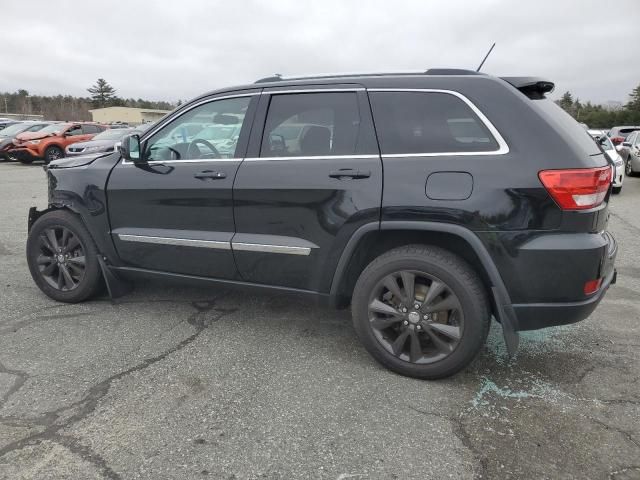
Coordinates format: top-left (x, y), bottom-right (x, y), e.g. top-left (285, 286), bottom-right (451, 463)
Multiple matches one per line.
top-left (27, 210), bottom-right (102, 303)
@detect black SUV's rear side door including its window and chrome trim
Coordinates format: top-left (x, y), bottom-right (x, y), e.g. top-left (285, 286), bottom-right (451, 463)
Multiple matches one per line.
top-left (232, 85), bottom-right (382, 292)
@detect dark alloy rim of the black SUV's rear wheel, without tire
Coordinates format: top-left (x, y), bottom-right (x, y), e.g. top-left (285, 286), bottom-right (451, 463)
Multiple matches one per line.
top-left (369, 270), bottom-right (464, 364)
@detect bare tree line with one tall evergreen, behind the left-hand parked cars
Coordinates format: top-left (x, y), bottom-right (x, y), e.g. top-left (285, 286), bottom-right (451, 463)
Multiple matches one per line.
top-left (0, 78), bottom-right (181, 120)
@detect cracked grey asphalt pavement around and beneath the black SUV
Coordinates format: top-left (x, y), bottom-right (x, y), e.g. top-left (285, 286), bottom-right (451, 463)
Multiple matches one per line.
top-left (0, 163), bottom-right (640, 480)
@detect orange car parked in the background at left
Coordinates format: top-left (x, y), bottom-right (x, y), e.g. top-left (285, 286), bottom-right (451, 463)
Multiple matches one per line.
top-left (8, 122), bottom-right (106, 163)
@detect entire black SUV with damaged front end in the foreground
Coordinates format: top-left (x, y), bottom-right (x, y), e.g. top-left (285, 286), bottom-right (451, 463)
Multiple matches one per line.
top-left (27, 70), bottom-right (617, 378)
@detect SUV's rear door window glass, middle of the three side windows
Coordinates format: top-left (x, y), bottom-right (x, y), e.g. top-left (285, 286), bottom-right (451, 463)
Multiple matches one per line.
top-left (260, 92), bottom-right (360, 157)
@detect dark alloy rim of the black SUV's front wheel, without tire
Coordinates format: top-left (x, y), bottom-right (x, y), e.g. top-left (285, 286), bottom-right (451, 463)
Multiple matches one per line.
top-left (37, 226), bottom-right (86, 291)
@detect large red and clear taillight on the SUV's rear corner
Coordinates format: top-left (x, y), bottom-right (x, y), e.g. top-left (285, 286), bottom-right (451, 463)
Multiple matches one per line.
top-left (538, 166), bottom-right (611, 210)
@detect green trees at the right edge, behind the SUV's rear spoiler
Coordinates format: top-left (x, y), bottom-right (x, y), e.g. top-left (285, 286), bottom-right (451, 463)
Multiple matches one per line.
top-left (556, 85), bottom-right (640, 128)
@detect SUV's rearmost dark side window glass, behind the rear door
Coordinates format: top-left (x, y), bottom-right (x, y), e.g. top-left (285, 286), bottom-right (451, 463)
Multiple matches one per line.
top-left (370, 92), bottom-right (498, 154)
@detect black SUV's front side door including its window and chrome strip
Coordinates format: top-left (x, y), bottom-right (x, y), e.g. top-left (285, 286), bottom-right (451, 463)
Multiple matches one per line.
top-left (107, 91), bottom-right (259, 279)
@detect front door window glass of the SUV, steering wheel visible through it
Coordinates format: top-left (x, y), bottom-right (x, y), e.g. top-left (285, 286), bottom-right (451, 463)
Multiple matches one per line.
top-left (145, 97), bottom-right (251, 160)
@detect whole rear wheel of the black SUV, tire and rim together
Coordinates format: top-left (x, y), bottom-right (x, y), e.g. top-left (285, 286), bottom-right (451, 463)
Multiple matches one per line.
top-left (351, 245), bottom-right (490, 380)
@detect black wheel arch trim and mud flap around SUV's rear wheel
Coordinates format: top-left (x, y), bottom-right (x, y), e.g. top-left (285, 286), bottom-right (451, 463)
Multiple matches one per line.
top-left (329, 221), bottom-right (518, 354)
